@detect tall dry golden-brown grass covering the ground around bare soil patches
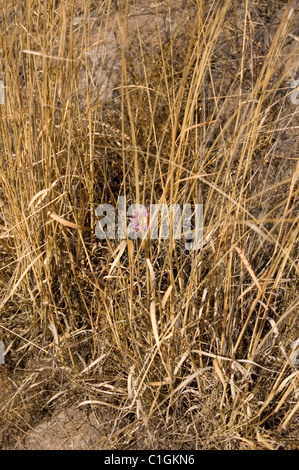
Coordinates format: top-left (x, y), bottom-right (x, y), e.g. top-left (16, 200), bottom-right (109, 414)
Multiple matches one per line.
top-left (0, 0), bottom-right (299, 449)
